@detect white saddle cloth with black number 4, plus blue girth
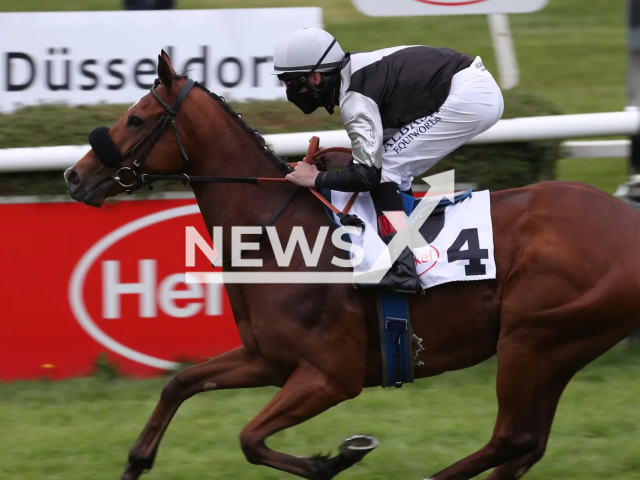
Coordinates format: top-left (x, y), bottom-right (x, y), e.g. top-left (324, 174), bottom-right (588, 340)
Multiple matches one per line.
top-left (322, 190), bottom-right (496, 387)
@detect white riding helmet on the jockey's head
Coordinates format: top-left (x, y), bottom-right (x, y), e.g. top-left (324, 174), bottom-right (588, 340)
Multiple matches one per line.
top-left (271, 28), bottom-right (344, 75)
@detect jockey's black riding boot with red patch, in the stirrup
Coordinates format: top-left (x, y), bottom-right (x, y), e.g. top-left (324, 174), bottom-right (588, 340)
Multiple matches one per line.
top-left (356, 182), bottom-right (421, 293)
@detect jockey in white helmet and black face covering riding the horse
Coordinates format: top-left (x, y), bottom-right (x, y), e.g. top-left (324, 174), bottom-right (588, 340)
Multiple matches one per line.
top-left (272, 28), bottom-right (504, 292)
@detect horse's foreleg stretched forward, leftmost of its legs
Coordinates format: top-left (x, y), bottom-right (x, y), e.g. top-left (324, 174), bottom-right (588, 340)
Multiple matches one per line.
top-left (122, 347), bottom-right (271, 480)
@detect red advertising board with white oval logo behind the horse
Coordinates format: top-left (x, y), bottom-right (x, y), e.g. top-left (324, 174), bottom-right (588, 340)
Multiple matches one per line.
top-left (0, 200), bottom-right (240, 380)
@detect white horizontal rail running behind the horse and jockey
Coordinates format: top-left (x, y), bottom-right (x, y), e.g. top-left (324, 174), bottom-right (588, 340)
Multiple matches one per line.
top-left (0, 109), bottom-right (640, 173)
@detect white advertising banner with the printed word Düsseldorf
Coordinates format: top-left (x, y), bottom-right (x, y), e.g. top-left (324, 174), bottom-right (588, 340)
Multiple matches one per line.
top-left (0, 8), bottom-right (322, 111)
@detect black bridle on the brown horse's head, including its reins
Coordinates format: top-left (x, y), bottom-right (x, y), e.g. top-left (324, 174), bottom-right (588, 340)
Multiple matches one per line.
top-left (89, 78), bottom-right (292, 194)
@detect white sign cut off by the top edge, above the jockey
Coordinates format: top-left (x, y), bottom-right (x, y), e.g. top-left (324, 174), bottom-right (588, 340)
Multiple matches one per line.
top-left (352, 0), bottom-right (549, 17)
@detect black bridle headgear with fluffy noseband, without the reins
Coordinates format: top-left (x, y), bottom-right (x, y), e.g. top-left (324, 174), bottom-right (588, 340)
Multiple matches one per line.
top-left (89, 78), bottom-right (196, 194)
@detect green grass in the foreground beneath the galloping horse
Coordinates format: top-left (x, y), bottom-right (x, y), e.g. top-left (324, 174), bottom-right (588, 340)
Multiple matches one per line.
top-left (0, 346), bottom-right (640, 480)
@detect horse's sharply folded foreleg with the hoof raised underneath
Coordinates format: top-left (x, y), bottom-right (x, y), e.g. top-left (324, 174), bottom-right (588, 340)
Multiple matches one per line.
top-left (240, 364), bottom-right (377, 480)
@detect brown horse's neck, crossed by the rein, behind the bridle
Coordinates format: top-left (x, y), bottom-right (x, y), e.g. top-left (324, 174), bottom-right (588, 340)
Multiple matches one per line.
top-left (189, 100), bottom-right (302, 259)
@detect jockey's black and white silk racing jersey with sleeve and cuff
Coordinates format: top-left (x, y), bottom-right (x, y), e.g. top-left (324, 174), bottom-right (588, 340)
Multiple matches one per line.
top-left (316, 46), bottom-right (473, 192)
